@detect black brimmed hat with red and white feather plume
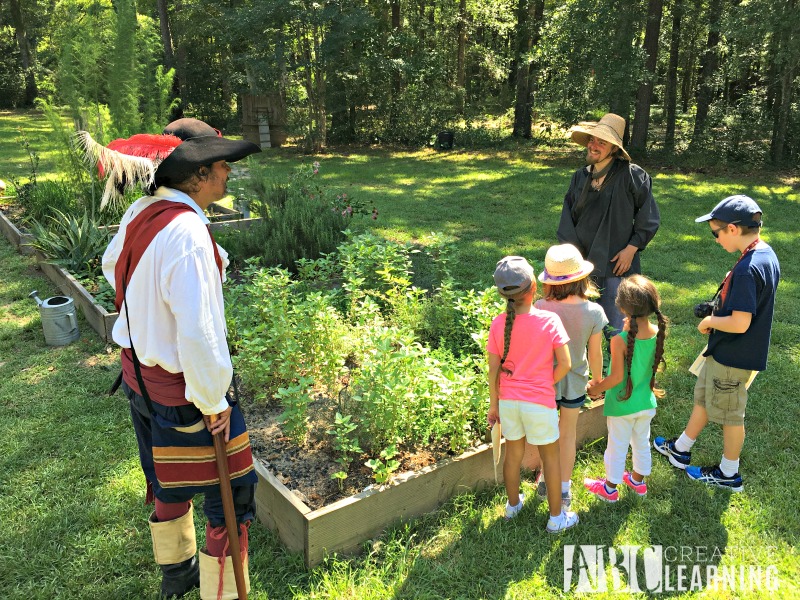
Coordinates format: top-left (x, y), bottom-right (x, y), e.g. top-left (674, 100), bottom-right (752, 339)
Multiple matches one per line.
top-left (77, 119), bottom-right (261, 209)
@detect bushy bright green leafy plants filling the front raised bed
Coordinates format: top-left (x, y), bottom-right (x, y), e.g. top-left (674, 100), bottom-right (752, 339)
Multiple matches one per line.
top-left (227, 234), bottom-right (500, 464)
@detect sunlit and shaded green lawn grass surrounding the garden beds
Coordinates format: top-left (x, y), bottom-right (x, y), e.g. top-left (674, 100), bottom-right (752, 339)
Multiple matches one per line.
top-left (0, 113), bottom-right (800, 599)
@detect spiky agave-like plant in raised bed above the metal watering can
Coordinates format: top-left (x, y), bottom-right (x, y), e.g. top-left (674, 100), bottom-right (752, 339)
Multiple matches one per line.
top-left (31, 209), bottom-right (109, 275)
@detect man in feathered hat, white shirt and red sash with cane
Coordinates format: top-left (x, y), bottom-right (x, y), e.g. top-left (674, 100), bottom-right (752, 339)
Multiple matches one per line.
top-left (82, 119), bottom-right (260, 599)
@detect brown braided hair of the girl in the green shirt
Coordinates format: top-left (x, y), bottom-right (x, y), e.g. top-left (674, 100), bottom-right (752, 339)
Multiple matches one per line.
top-left (616, 275), bottom-right (667, 400)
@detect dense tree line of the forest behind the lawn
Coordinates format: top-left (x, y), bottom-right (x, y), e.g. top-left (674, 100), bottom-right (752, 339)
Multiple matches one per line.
top-left (0, 0), bottom-right (800, 166)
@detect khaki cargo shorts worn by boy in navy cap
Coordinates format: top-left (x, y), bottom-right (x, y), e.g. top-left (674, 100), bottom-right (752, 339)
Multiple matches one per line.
top-left (694, 356), bottom-right (753, 425)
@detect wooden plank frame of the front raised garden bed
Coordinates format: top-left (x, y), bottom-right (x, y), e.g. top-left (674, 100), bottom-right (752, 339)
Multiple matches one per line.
top-left (255, 400), bottom-right (606, 568)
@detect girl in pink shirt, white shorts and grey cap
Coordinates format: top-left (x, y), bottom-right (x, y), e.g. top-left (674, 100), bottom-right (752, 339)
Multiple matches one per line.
top-left (487, 256), bottom-right (578, 533)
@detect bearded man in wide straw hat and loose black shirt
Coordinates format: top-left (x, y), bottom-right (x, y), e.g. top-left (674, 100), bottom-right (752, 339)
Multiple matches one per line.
top-left (557, 113), bottom-right (661, 337)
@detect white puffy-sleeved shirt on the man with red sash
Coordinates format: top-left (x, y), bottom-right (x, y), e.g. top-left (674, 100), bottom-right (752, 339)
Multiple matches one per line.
top-left (103, 187), bottom-right (233, 415)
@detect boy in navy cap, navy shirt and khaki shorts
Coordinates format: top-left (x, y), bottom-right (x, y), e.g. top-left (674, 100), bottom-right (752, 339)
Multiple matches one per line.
top-left (653, 195), bottom-right (780, 492)
